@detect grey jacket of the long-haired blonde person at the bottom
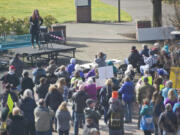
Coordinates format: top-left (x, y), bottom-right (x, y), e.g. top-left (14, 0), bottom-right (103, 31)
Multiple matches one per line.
top-left (56, 109), bottom-right (71, 131)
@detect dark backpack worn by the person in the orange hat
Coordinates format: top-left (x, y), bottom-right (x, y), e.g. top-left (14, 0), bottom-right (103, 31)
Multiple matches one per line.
top-left (109, 112), bottom-right (123, 129)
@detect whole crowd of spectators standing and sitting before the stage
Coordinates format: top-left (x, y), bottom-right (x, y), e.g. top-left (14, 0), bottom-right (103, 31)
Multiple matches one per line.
top-left (0, 42), bottom-right (180, 135)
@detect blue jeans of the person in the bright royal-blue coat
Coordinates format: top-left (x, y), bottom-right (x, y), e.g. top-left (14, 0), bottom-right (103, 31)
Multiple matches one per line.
top-left (124, 102), bottom-right (132, 122)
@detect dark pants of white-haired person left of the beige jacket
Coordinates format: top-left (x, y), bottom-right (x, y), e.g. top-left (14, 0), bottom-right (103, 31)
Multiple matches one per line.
top-left (25, 121), bottom-right (36, 135)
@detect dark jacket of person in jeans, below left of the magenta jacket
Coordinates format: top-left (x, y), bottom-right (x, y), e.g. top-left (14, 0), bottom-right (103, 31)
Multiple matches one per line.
top-left (72, 91), bottom-right (88, 113)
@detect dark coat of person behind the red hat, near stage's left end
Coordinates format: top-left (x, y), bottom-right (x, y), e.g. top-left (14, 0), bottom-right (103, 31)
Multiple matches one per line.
top-left (9, 57), bottom-right (24, 77)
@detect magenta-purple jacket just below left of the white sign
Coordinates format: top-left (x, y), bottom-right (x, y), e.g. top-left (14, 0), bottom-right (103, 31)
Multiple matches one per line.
top-left (84, 84), bottom-right (97, 100)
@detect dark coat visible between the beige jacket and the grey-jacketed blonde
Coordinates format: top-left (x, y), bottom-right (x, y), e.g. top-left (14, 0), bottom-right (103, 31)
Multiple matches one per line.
top-left (45, 90), bottom-right (63, 112)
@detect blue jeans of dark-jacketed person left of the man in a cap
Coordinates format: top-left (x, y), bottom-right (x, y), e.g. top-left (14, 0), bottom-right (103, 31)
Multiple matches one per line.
top-left (74, 112), bottom-right (84, 135)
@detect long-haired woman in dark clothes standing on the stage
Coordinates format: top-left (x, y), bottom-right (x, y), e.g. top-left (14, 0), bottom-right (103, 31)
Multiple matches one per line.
top-left (30, 9), bottom-right (43, 49)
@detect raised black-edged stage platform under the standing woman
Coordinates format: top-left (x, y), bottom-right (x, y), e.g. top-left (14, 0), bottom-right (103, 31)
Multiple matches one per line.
top-left (11, 44), bottom-right (76, 65)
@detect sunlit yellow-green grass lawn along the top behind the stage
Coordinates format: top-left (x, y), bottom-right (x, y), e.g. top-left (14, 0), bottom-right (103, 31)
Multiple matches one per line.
top-left (0, 0), bottom-right (132, 23)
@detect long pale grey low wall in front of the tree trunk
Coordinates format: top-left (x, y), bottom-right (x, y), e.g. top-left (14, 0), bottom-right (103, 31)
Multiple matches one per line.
top-left (136, 27), bottom-right (174, 41)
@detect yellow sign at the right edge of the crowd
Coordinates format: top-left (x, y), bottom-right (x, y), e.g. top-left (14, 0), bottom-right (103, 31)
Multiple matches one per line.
top-left (170, 67), bottom-right (180, 89)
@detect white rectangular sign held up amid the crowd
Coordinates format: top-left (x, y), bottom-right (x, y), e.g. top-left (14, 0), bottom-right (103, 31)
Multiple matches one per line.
top-left (98, 66), bottom-right (114, 79)
